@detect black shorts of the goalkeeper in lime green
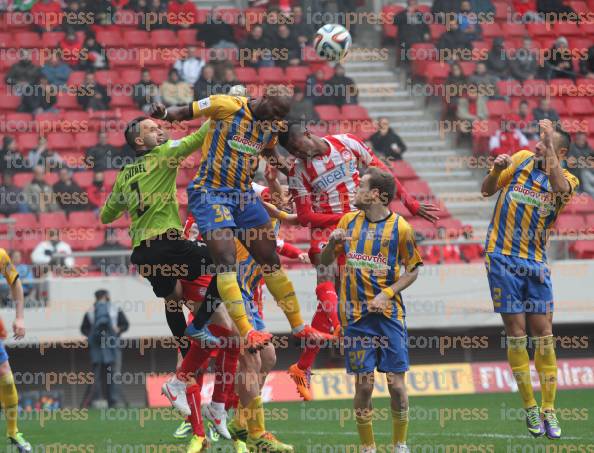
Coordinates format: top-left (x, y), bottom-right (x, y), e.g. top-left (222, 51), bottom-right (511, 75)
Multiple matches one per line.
top-left (130, 230), bottom-right (214, 297)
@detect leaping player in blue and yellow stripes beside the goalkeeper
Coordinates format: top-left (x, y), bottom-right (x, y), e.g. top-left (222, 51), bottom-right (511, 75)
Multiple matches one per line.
top-left (152, 92), bottom-right (330, 349)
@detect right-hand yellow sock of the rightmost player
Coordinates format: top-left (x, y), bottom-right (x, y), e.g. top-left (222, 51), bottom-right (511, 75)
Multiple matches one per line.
top-left (534, 335), bottom-right (557, 411)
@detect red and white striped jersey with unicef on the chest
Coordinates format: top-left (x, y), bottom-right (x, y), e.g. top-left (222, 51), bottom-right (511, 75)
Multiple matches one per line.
top-left (289, 134), bottom-right (381, 214)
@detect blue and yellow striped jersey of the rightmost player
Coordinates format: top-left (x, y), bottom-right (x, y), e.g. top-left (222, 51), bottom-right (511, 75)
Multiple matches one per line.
top-left (485, 150), bottom-right (579, 262)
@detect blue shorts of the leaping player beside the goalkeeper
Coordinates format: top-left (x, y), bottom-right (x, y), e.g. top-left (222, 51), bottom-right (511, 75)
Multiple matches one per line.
top-left (188, 183), bottom-right (270, 234)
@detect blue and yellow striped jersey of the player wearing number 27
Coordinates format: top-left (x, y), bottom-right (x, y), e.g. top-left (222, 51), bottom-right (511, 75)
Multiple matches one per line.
top-left (337, 211), bottom-right (423, 326)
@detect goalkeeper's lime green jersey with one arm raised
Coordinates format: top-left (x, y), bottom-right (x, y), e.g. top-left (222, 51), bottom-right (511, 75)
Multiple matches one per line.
top-left (101, 121), bottom-right (209, 247)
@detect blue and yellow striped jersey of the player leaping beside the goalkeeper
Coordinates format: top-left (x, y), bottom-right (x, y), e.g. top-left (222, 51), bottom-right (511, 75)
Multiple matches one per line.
top-left (192, 95), bottom-right (277, 191)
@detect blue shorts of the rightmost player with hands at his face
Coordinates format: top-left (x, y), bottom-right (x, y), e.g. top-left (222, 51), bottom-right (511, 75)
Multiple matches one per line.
top-left (485, 253), bottom-right (553, 314)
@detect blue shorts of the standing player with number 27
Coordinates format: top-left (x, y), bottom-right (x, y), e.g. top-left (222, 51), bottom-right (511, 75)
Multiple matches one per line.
top-left (344, 313), bottom-right (409, 374)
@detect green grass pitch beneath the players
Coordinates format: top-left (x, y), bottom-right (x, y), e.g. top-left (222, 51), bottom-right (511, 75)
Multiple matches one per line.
top-left (12, 390), bottom-right (594, 453)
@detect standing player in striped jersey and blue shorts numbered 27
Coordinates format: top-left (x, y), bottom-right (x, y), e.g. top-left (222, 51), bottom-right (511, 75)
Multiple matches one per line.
top-left (321, 168), bottom-right (423, 453)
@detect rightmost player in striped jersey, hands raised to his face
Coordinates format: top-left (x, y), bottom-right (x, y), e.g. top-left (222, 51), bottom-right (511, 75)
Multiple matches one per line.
top-left (482, 120), bottom-right (579, 439)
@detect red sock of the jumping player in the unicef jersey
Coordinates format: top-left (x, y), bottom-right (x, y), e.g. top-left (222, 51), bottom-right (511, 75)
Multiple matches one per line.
top-left (297, 282), bottom-right (340, 370)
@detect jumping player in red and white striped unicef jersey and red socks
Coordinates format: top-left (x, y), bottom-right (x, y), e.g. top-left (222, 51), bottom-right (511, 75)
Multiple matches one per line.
top-left (279, 123), bottom-right (438, 400)
